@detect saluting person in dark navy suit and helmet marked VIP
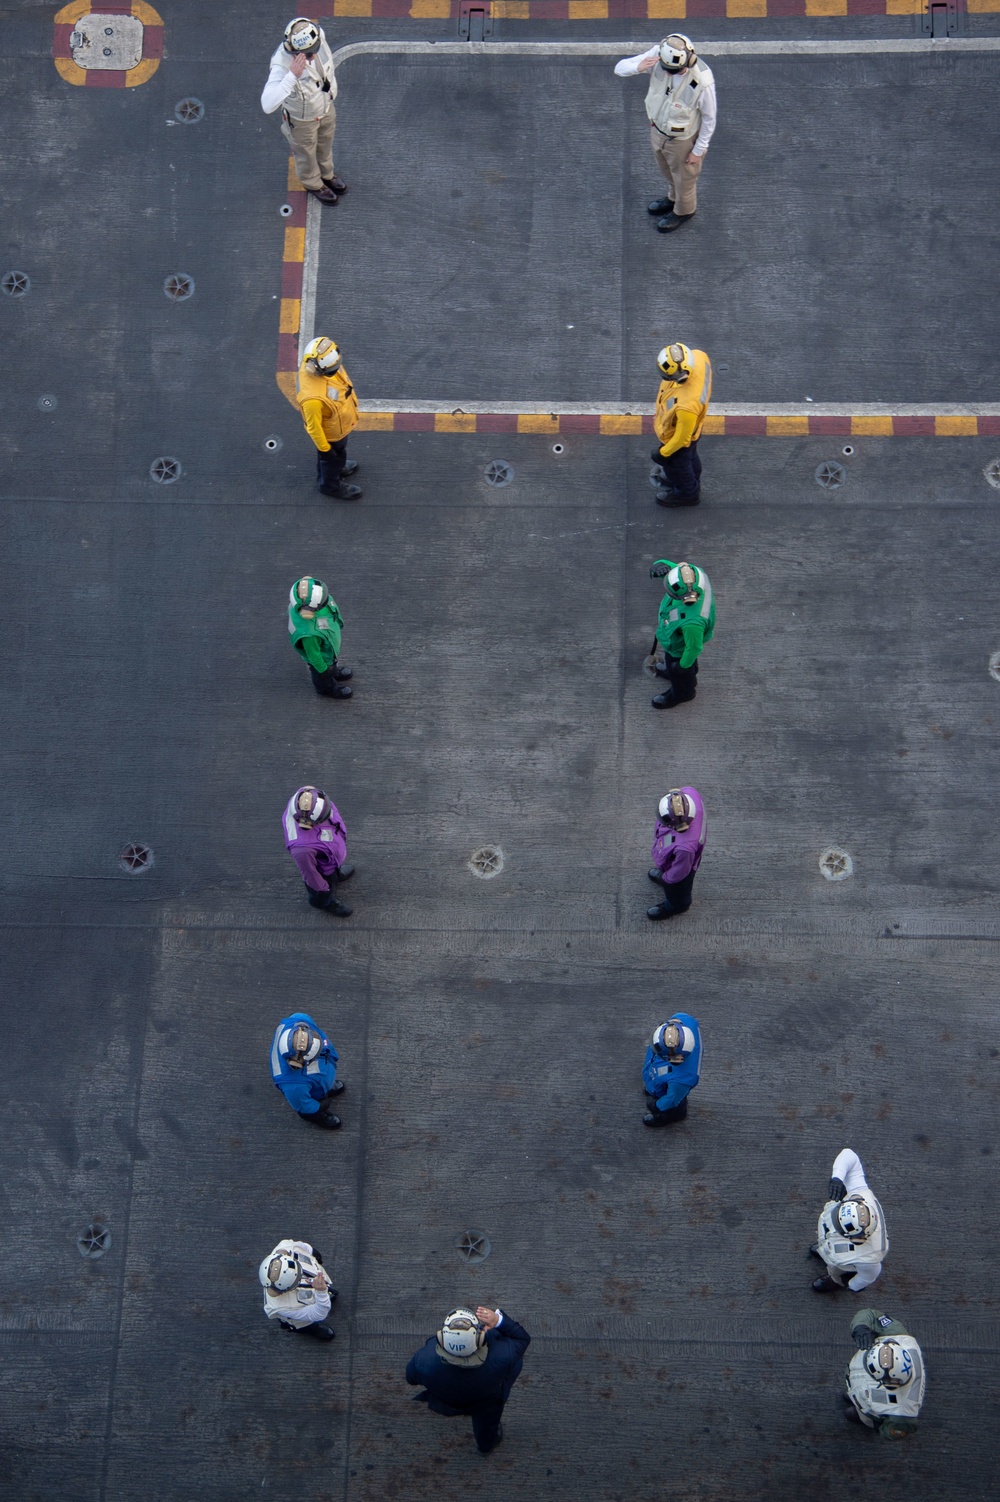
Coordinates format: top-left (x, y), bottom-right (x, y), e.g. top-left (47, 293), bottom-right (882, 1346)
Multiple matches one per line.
top-left (407, 1308), bottom-right (532, 1455)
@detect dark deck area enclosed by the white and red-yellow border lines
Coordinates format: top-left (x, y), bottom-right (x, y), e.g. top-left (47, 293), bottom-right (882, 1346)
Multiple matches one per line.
top-left (315, 54), bottom-right (1000, 404)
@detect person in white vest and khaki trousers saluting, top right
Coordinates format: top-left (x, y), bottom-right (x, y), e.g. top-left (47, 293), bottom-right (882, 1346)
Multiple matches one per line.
top-left (614, 32), bottom-right (716, 234)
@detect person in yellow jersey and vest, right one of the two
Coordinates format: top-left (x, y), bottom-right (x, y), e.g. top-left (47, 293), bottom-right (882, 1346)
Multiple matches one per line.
top-left (653, 344), bottom-right (712, 506)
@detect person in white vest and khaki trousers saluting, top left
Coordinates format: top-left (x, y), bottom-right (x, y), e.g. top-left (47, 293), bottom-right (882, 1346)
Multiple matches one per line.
top-left (260, 15), bottom-right (347, 203)
